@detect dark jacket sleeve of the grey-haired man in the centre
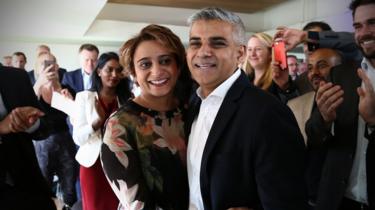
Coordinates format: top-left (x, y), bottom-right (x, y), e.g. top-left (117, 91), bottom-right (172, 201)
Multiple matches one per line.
top-left (253, 104), bottom-right (307, 210)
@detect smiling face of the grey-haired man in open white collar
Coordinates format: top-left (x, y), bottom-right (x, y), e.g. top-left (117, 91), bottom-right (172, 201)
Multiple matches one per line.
top-left (186, 20), bottom-right (245, 96)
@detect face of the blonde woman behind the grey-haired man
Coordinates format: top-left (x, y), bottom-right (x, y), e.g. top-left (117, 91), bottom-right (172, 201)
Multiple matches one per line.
top-left (247, 37), bottom-right (271, 69)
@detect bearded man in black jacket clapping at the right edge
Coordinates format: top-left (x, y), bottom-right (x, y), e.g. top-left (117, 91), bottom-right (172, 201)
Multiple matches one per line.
top-left (306, 0), bottom-right (375, 210)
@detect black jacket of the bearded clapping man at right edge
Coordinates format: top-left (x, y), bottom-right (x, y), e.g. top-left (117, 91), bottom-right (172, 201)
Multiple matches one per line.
top-left (306, 63), bottom-right (375, 210)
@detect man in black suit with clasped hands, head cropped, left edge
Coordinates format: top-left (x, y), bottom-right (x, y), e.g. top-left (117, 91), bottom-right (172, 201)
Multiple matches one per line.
top-left (0, 67), bottom-right (56, 210)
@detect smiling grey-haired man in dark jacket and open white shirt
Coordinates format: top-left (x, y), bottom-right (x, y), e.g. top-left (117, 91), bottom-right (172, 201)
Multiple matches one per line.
top-left (186, 8), bottom-right (307, 210)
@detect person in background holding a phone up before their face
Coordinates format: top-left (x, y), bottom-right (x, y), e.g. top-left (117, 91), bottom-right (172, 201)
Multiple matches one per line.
top-left (34, 53), bottom-right (77, 208)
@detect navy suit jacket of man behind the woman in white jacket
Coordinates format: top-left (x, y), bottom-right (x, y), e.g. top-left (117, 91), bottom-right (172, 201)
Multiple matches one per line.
top-left (61, 69), bottom-right (84, 97)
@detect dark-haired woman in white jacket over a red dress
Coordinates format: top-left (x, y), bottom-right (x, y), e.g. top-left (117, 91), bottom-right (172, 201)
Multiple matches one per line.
top-left (71, 52), bottom-right (131, 210)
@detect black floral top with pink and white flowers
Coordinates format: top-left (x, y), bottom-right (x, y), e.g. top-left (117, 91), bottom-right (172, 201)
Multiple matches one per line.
top-left (101, 100), bottom-right (189, 210)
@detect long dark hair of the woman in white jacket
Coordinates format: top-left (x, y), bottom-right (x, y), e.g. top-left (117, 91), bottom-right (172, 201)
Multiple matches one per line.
top-left (90, 52), bottom-right (133, 105)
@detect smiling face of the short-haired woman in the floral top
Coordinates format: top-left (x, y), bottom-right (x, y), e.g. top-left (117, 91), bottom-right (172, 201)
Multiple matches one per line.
top-left (133, 40), bottom-right (179, 99)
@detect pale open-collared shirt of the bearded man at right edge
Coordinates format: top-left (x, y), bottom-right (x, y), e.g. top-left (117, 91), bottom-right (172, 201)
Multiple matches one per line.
top-left (345, 58), bottom-right (375, 204)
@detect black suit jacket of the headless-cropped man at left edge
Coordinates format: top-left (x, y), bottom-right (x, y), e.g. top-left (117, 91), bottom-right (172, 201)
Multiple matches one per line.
top-left (0, 67), bottom-right (52, 209)
